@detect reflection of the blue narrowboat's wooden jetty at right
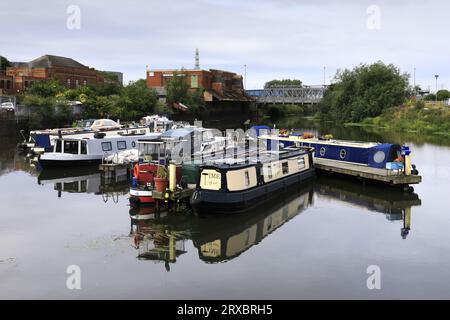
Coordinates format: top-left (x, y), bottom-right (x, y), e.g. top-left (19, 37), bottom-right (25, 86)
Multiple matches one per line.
top-left (314, 176), bottom-right (422, 239)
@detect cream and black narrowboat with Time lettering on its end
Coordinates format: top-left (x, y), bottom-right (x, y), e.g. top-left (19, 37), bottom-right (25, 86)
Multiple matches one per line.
top-left (190, 146), bottom-right (314, 214)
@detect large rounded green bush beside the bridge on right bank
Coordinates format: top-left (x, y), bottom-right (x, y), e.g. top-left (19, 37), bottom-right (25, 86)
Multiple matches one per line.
top-left (319, 62), bottom-right (410, 122)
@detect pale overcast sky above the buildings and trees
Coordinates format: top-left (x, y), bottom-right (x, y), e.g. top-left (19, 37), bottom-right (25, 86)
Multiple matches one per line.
top-left (0, 0), bottom-right (450, 90)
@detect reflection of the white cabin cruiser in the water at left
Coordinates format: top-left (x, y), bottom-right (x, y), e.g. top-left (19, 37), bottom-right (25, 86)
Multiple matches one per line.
top-left (38, 167), bottom-right (130, 203)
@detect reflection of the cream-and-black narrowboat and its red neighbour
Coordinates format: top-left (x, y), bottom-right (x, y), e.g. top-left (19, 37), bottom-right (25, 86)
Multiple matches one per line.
top-left (130, 183), bottom-right (313, 270)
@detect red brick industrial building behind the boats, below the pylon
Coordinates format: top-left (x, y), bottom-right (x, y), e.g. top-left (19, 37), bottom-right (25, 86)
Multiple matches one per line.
top-left (147, 69), bottom-right (253, 102)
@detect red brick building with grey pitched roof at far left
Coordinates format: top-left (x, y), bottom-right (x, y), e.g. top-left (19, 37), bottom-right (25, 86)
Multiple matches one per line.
top-left (0, 55), bottom-right (105, 93)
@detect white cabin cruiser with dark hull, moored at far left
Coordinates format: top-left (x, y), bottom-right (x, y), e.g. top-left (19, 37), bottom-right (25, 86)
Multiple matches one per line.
top-left (39, 132), bottom-right (160, 168)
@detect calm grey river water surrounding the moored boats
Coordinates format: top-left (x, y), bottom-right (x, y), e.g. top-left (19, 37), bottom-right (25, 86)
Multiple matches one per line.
top-left (0, 123), bottom-right (450, 299)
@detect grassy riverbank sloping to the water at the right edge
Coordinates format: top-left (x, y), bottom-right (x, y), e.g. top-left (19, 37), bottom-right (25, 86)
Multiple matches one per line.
top-left (345, 104), bottom-right (450, 137)
